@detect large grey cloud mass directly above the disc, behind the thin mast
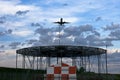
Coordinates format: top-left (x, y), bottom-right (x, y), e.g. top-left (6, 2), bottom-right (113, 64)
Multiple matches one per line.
top-left (35, 24), bottom-right (112, 46)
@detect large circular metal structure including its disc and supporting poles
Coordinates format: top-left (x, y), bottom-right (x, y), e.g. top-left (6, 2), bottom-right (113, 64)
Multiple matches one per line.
top-left (16, 45), bottom-right (108, 74)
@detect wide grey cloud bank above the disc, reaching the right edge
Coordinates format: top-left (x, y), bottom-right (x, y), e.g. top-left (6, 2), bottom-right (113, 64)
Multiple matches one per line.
top-left (27, 23), bottom-right (120, 46)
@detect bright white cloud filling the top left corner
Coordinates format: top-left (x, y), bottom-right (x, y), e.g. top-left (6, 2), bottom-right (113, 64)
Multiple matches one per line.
top-left (0, 0), bottom-right (34, 15)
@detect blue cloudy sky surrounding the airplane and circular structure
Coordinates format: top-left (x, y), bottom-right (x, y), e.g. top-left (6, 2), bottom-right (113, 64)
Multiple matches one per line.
top-left (0, 0), bottom-right (120, 73)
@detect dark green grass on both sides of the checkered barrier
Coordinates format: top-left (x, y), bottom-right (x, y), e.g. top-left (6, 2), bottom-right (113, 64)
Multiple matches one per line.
top-left (0, 67), bottom-right (120, 80)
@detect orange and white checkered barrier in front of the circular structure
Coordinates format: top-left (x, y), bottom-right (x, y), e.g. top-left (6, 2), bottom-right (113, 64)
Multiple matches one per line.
top-left (47, 63), bottom-right (76, 80)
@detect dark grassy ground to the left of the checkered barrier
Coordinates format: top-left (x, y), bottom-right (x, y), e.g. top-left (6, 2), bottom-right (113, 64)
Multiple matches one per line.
top-left (0, 67), bottom-right (46, 80)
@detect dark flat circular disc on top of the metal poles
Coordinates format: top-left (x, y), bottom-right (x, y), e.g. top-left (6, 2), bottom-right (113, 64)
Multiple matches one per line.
top-left (17, 45), bottom-right (106, 57)
